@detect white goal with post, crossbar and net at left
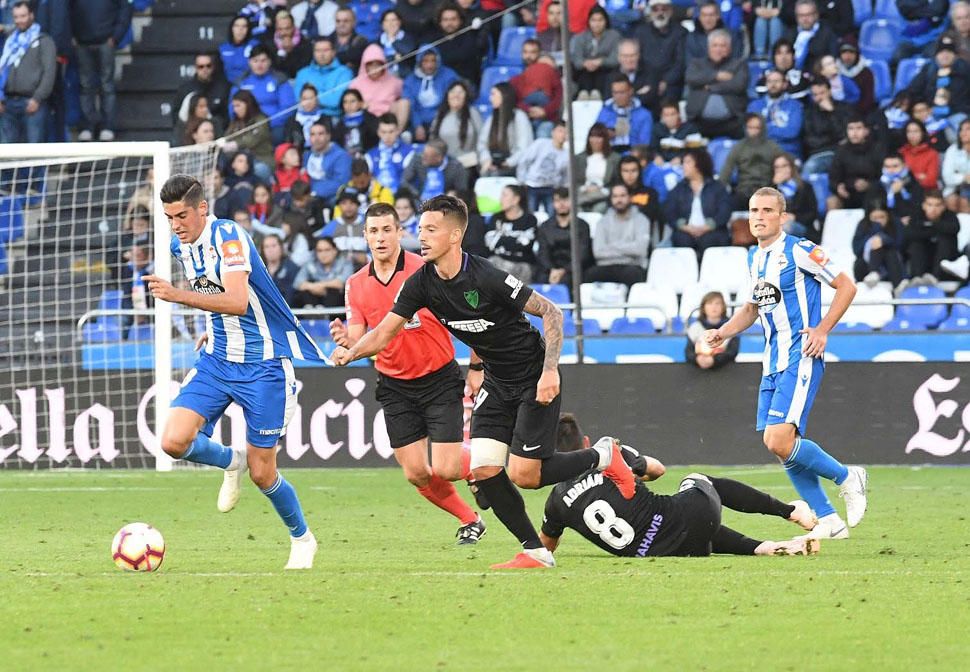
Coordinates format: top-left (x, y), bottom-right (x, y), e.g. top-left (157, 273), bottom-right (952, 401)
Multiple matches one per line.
top-left (0, 142), bottom-right (218, 469)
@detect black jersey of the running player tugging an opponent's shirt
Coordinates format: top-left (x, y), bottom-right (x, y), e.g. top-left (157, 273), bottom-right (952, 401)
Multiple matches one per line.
top-left (391, 252), bottom-right (546, 384)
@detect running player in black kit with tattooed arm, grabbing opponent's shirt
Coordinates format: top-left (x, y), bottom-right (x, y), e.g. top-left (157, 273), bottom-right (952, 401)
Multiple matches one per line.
top-left (332, 196), bottom-right (635, 569)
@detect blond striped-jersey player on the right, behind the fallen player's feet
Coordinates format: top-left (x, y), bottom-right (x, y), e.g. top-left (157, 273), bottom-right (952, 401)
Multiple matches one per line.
top-left (705, 187), bottom-right (868, 539)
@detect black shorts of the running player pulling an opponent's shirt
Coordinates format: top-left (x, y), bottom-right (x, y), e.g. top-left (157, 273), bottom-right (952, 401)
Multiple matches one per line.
top-left (471, 374), bottom-right (562, 460)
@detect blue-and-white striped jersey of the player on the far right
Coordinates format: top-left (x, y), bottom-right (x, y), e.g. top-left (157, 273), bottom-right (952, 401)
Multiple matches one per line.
top-left (747, 232), bottom-right (840, 376)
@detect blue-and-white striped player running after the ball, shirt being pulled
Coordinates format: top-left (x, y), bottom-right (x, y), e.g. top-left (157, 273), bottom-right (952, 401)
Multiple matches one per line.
top-left (144, 175), bottom-right (324, 569)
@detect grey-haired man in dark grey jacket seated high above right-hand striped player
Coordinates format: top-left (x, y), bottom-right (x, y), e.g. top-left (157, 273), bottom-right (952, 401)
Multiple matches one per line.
top-left (686, 30), bottom-right (748, 138)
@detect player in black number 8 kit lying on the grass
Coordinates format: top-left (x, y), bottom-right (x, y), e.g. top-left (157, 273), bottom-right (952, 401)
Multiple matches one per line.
top-left (541, 415), bottom-right (819, 558)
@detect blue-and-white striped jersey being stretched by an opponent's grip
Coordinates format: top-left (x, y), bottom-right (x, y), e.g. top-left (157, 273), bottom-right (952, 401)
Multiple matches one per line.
top-left (170, 219), bottom-right (323, 363)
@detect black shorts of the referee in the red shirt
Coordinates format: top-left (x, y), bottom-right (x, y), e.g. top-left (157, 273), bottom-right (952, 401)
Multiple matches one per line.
top-left (375, 360), bottom-right (465, 449)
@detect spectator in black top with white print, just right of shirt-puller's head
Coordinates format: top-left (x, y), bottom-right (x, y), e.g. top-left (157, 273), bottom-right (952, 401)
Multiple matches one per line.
top-left (485, 184), bottom-right (539, 283)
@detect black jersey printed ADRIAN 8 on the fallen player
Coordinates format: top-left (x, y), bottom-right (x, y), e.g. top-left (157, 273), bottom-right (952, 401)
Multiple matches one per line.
top-left (542, 471), bottom-right (694, 558)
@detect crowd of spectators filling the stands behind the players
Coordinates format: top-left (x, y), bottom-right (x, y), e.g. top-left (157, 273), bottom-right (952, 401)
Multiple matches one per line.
top-left (0, 0), bottom-right (970, 320)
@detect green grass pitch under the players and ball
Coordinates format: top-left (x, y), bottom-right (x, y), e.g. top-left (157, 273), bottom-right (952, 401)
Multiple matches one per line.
top-left (0, 467), bottom-right (970, 672)
